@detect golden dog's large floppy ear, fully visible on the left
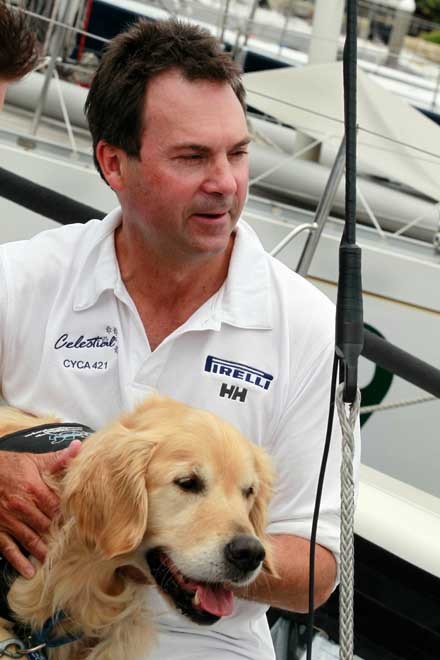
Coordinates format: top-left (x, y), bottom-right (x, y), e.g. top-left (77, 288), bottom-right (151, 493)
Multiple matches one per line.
top-left (61, 424), bottom-right (156, 559)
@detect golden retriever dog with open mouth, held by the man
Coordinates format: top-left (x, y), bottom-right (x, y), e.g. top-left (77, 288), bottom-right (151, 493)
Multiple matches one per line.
top-left (0, 395), bottom-right (274, 660)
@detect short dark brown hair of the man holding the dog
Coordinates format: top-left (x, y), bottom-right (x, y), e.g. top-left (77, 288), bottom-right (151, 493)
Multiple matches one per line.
top-left (85, 19), bottom-right (246, 176)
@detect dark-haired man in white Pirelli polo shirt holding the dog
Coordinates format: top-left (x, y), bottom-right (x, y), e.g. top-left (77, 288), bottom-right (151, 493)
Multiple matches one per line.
top-left (0, 21), bottom-right (358, 660)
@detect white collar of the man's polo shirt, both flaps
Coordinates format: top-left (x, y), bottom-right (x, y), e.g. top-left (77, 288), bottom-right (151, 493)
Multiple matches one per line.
top-left (74, 208), bottom-right (273, 329)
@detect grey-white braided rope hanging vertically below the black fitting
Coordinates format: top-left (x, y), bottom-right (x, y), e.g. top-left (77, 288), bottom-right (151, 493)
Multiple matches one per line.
top-left (336, 383), bottom-right (361, 660)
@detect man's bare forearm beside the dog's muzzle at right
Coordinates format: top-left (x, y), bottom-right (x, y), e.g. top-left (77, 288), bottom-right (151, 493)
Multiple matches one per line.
top-left (234, 534), bottom-right (336, 612)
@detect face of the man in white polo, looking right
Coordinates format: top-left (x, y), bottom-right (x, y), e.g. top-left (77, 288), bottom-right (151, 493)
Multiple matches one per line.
top-left (118, 71), bottom-right (249, 261)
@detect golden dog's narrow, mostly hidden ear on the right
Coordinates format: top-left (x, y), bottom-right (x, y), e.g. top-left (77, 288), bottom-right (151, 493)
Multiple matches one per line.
top-left (249, 447), bottom-right (277, 576)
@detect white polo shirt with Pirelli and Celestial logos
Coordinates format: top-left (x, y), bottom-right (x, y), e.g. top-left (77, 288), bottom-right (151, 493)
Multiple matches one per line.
top-left (0, 209), bottom-right (358, 660)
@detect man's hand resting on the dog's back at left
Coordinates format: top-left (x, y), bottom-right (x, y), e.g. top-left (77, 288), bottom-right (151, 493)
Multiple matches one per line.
top-left (0, 440), bottom-right (81, 578)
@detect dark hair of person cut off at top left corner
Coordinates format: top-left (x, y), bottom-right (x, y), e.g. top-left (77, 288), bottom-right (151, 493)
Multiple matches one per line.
top-left (0, 0), bottom-right (39, 80)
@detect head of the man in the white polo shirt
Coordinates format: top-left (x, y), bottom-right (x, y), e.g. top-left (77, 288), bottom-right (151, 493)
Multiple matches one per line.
top-left (86, 20), bottom-right (249, 258)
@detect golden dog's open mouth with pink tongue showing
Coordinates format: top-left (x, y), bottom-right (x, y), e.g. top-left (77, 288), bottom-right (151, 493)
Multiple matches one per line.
top-left (147, 548), bottom-right (234, 625)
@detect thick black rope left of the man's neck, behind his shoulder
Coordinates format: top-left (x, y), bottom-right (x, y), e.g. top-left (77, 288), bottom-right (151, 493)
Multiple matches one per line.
top-left (0, 167), bottom-right (106, 225)
